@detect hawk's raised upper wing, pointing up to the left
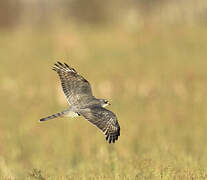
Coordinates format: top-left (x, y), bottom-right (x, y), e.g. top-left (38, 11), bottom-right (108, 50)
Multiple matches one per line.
top-left (53, 62), bottom-right (93, 105)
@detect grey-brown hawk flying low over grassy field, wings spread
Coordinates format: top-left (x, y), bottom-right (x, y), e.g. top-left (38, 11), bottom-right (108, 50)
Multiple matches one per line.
top-left (40, 62), bottom-right (120, 144)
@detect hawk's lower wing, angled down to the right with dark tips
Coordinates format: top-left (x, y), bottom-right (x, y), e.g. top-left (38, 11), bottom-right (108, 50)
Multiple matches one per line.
top-left (80, 106), bottom-right (120, 143)
